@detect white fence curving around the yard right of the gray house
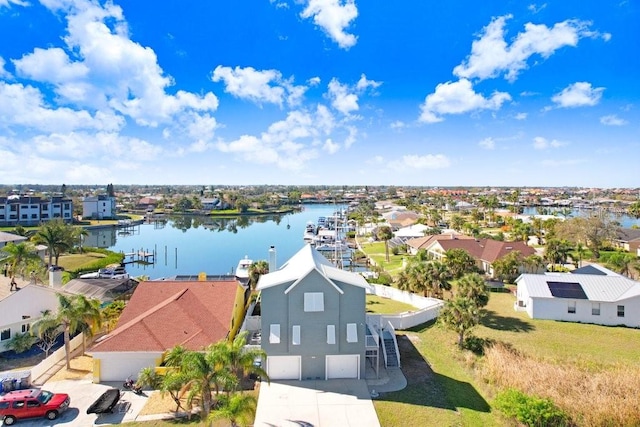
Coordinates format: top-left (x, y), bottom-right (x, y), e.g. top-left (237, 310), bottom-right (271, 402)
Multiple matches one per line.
top-left (367, 284), bottom-right (444, 329)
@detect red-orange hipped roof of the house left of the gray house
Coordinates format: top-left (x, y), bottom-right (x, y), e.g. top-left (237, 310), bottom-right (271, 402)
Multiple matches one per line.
top-left (92, 280), bottom-right (239, 352)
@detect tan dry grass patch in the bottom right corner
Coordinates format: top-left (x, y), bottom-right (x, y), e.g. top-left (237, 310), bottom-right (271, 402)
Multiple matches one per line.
top-left (483, 344), bottom-right (640, 427)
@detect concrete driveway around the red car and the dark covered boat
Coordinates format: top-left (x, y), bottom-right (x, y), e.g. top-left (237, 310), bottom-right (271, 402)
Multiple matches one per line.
top-left (1, 380), bottom-right (148, 427)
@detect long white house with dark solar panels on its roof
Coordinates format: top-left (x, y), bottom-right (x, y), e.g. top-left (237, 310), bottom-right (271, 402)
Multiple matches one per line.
top-left (515, 269), bottom-right (640, 328)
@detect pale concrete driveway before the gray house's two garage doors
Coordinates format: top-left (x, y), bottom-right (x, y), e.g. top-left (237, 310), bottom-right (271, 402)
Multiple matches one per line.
top-left (254, 379), bottom-right (380, 427)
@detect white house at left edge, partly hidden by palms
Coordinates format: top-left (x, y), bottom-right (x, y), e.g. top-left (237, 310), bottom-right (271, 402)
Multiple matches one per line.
top-left (0, 285), bottom-right (60, 352)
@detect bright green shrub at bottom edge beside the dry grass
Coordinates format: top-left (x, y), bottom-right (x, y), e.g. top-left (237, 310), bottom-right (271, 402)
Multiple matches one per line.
top-left (494, 389), bottom-right (569, 427)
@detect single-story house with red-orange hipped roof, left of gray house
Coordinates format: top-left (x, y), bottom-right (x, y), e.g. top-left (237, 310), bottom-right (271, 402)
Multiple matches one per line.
top-left (90, 276), bottom-right (245, 382)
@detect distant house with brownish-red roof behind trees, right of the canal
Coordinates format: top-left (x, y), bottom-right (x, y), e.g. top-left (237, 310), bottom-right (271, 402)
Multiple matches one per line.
top-left (425, 238), bottom-right (536, 277)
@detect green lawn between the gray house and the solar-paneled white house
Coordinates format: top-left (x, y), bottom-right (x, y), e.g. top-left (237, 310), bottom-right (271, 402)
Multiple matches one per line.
top-left (374, 293), bottom-right (640, 427)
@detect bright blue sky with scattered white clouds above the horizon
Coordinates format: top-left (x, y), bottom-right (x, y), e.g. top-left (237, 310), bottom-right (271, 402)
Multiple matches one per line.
top-left (0, 0), bottom-right (640, 187)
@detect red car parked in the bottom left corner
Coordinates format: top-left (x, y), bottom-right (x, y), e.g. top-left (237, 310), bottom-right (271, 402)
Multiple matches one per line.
top-left (0, 389), bottom-right (71, 426)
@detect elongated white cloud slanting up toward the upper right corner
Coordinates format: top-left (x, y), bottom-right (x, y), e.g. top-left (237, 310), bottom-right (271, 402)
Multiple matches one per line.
top-left (453, 15), bottom-right (599, 81)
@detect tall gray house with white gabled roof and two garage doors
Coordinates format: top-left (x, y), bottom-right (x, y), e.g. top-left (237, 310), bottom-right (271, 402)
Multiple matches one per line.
top-left (257, 245), bottom-right (370, 380)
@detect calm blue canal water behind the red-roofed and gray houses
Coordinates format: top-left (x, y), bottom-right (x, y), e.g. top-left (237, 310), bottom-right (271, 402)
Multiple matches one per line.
top-left (84, 204), bottom-right (344, 279)
